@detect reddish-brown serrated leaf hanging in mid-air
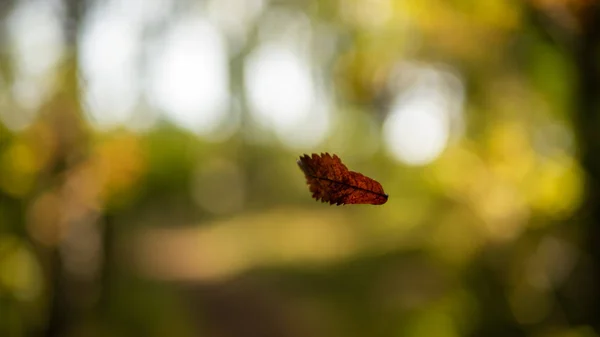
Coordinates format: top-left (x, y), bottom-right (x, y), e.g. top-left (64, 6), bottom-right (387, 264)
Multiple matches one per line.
top-left (298, 153), bottom-right (388, 205)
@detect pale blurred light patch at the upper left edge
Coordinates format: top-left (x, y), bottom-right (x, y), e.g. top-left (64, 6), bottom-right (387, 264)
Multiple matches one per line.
top-left (0, 1), bottom-right (64, 130)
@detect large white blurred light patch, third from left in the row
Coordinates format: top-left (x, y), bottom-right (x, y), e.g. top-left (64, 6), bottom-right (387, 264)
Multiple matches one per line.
top-left (148, 18), bottom-right (230, 134)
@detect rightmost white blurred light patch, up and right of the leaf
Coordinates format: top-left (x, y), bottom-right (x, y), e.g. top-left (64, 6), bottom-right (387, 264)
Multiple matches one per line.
top-left (383, 64), bottom-right (463, 165)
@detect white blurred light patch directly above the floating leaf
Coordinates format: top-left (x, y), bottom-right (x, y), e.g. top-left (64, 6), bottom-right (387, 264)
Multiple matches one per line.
top-left (245, 44), bottom-right (330, 147)
